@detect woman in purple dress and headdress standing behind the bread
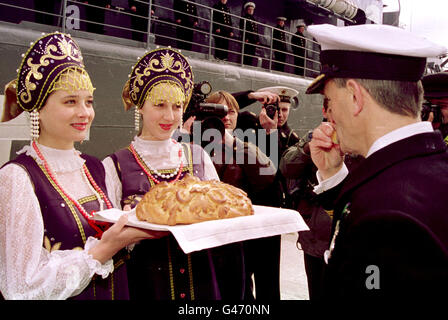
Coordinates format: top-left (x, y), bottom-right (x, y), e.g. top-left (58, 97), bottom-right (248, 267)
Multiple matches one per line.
top-left (103, 48), bottom-right (228, 301)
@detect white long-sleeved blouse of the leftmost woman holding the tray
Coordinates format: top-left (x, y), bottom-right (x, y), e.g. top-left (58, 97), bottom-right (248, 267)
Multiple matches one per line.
top-left (0, 144), bottom-right (113, 299)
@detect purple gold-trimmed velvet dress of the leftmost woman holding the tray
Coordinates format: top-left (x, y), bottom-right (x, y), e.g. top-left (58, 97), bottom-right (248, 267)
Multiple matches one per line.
top-left (8, 154), bottom-right (129, 300)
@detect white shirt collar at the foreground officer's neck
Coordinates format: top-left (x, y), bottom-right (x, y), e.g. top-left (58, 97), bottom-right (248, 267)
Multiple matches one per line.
top-left (366, 121), bottom-right (434, 158)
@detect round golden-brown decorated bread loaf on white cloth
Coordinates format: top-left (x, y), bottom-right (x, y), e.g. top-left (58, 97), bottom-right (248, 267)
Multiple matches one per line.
top-left (136, 174), bottom-right (254, 226)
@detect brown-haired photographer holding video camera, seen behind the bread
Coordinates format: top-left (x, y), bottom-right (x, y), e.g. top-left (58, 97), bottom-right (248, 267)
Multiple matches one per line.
top-left (176, 81), bottom-right (277, 204)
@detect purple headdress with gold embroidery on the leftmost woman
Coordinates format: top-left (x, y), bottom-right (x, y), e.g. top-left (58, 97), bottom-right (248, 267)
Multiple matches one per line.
top-left (2, 32), bottom-right (95, 121)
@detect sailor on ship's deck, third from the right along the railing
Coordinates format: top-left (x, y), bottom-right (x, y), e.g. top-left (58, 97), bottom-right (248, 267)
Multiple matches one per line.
top-left (240, 2), bottom-right (260, 66)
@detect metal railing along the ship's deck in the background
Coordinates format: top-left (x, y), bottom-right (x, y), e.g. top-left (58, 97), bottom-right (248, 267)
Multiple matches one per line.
top-left (0, 0), bottom-right (320, 76)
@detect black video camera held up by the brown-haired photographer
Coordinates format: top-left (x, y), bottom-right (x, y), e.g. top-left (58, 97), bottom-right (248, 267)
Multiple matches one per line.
top-left (183, 81), bottom-right (229, 147)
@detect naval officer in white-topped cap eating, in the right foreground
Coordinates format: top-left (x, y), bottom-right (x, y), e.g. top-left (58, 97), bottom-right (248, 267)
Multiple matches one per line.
top-left (306, 24), bottom-right (448, 301)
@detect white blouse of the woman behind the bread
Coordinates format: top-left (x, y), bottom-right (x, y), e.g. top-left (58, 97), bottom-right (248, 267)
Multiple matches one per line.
top-left (103, 136), bottom-right (219, 208)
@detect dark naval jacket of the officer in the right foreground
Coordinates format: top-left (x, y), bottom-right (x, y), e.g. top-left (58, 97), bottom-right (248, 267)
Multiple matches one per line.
top-left (322, 132), bottom-right (448, 299)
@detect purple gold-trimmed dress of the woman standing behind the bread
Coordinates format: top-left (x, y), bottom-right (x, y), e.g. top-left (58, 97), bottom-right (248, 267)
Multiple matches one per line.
top-left (111, 143), bottom-right (220, 300)
